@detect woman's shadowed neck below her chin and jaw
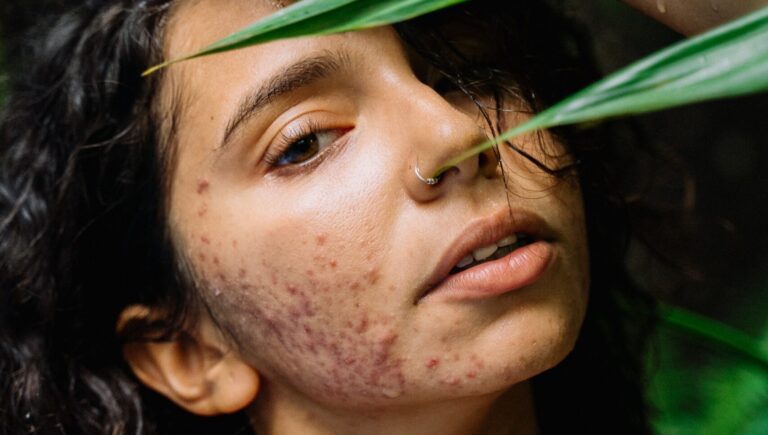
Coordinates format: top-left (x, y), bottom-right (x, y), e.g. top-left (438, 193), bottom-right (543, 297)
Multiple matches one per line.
top-left (251, 382), bottom-right (538, 435)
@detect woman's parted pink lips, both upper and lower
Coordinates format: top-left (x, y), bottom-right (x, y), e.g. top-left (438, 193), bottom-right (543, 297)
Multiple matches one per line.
top-left (416, 209), bottom-right (554, 303)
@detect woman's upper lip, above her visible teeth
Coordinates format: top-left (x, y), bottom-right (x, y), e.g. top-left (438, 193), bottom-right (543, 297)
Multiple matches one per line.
top-left (417, 208), bottom-right (552, 302)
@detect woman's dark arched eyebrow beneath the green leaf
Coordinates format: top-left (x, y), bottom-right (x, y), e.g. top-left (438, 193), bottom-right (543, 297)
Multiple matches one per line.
top-left (219, 51), bottom-right (349, 150)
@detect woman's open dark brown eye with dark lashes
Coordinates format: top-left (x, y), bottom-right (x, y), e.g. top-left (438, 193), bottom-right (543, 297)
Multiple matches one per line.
top-left (264, 123), bottom-right (349, 168)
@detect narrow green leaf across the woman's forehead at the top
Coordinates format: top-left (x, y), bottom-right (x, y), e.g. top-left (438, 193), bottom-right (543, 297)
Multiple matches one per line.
top-left (142, 0), bottom-right (468, 76)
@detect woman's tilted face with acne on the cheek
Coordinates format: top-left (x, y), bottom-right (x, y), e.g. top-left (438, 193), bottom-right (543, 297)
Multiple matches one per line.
top-left (166, 1), bottom-right (588, 416)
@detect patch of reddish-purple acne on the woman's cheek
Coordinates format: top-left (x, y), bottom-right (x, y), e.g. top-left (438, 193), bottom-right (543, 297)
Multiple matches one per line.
top-left (198, 234), bottom-right (406, 403)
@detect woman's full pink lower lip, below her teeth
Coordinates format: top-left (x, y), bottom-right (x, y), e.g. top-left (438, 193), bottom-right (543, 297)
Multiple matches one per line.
top-left (423, 241), bottom-right (554, 301)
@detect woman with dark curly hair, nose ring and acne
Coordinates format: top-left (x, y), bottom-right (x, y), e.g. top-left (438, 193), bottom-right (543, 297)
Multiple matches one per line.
top-left (0, 0), bottom-right (756, 434)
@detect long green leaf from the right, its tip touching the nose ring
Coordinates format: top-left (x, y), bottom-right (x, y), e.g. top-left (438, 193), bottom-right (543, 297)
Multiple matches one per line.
top-left (432, 4), bottom-right (768, 177)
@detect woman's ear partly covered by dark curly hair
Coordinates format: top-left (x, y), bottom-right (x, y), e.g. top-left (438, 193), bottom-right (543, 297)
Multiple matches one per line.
top-left (117, 305), bottom-right (259, 416)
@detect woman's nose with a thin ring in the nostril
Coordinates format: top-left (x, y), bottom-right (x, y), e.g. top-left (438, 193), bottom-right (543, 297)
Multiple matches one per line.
top-left (401, 83), bottom-right (500, 202)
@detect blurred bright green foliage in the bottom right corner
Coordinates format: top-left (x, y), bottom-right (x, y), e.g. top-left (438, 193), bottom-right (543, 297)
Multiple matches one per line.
top-left (648, 308), bottom-right (768, 435)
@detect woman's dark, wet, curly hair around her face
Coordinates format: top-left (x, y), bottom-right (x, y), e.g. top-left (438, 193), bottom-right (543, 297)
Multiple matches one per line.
top-left (0, 0), bottom-right (653, 434)
